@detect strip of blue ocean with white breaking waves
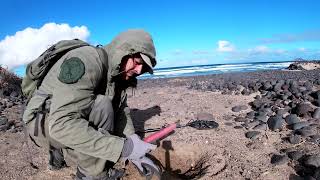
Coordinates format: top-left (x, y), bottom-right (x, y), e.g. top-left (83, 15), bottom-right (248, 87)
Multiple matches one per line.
top-left (138, 61), bottom-right (293, 79)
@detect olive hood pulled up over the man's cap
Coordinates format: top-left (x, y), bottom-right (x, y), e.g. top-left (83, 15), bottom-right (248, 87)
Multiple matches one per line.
top-left (103, 29), bottom-right (156, 78)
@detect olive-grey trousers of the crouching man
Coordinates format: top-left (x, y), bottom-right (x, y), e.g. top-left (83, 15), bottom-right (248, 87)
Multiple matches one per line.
top-left (27, 95), bottom-right (114, 177)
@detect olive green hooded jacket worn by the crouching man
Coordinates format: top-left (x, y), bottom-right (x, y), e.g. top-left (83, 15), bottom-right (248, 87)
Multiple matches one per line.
top-left (23, 30), bottom-right (156, 162)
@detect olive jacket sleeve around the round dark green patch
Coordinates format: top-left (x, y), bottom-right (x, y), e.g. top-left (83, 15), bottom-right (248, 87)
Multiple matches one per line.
top-left (49, 51), bottom-right (124, 162)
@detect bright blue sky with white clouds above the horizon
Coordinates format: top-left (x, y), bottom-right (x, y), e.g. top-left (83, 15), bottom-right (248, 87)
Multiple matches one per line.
top-left (0, 0), bottom-right (320, 75)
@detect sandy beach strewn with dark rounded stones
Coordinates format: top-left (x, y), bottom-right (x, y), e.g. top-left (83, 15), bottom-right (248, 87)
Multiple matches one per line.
top-left (0, 65), bottom-right (320, 180)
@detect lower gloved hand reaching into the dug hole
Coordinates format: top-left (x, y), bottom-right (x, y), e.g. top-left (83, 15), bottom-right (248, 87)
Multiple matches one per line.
top-left (131, 156), bottom-right (161, 179)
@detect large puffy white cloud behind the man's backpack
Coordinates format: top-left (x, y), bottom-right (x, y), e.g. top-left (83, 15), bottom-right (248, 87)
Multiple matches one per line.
top-left (0, 23), bottom-right (90, 69)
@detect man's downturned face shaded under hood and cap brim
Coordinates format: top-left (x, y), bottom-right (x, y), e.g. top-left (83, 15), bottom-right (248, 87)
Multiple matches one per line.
top-left (122, 54), bottom-right (145, 80)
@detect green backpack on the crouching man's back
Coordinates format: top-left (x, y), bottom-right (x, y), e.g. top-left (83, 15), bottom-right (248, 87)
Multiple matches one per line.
top-left (21, 39), bottom-right (101, 100)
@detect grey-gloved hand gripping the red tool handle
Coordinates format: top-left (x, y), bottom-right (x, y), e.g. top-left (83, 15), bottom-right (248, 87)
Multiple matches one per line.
top-left (121, 134), bottom-right (157, 161)
